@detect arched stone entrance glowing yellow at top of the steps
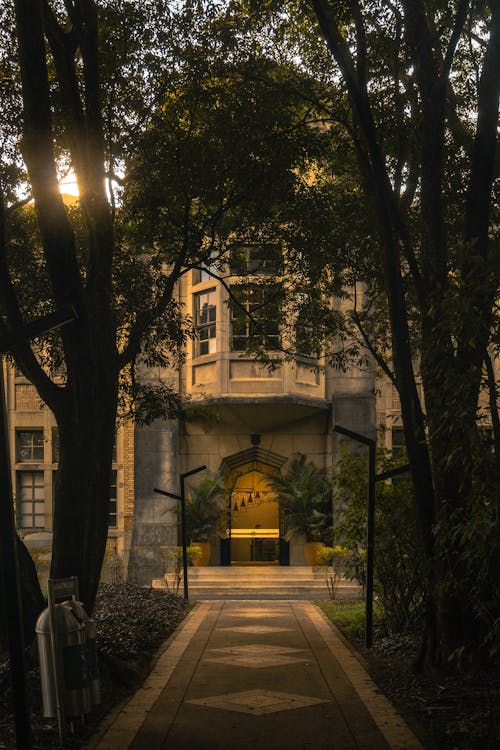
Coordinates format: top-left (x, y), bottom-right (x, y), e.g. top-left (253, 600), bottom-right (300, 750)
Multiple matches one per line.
top-left (221, 446), bottom-right (290, 565)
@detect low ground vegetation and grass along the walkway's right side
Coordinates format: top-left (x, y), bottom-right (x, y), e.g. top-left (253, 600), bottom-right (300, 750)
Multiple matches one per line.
top-left (320, 599), bottom-right (500, 750)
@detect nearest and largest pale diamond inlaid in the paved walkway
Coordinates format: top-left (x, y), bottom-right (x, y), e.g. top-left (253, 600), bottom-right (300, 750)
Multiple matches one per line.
top-left (187, 690), bottom-right (329, 716)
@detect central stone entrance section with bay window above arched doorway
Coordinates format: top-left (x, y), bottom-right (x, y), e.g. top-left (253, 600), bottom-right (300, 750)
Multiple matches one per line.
top-left (129, 268), bottom-right (375, 583)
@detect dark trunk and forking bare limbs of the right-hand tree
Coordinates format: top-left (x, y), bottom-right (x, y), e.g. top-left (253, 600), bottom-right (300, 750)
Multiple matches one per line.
top-left (313, 0), bottom-right (500, 671)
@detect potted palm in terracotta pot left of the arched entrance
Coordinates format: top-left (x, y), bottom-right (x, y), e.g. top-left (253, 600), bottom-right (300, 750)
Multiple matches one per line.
top-left (186, 475), bottom-right (226, 565)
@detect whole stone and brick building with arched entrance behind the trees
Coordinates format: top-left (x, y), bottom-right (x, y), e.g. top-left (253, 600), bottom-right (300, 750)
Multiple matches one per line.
top-left (4, 258), bottom-right (498, 584)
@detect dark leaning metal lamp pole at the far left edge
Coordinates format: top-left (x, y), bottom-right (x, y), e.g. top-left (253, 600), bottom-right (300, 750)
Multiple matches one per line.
top-left (0, 359), bottom-right (31, 750)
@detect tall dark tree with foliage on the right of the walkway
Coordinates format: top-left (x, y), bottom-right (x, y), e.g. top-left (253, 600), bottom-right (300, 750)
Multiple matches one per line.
top-left (274, 0), bottom-right (500, 669)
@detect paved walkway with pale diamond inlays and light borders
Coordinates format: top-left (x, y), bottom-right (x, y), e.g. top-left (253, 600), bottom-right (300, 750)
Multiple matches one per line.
top-left (93, 600), bottom-right (423, 750)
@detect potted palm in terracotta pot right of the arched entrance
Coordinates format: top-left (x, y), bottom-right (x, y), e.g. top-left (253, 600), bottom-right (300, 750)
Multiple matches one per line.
top-left (269, 453), bottom-right (332, 565)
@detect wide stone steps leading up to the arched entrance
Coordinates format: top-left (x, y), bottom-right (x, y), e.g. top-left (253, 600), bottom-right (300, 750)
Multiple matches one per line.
top-left (153, 565), bottom-right (361, 600)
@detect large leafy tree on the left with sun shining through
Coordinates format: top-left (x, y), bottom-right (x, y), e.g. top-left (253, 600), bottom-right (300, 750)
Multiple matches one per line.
top-left (0, 0), bottom-right (330, 630)
